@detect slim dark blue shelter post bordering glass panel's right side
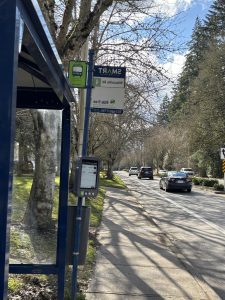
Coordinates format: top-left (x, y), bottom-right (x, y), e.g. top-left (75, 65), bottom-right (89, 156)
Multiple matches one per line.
top-left (56, 106), bottom-right (70, 300)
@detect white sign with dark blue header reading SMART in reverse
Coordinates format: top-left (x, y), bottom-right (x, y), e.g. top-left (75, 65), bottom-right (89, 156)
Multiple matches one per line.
top-left (91, 66), bottom-right (126, 114)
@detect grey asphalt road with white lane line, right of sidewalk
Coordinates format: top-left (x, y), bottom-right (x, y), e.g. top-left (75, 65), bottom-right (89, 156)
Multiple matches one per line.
top-left (117, 171), bottom-right (225, 299)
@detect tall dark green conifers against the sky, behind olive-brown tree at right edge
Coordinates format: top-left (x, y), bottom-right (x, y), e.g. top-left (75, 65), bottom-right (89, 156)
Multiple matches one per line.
top-left (169, 0), bottom-right (225, 120)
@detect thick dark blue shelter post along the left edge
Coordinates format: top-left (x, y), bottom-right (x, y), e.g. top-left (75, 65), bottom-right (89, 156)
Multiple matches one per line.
top-left (0, 0), bottom-right (20, 300)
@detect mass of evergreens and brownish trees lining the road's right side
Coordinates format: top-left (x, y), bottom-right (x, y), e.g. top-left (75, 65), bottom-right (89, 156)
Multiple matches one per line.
top-left (119, 0), bottom-right (225, 178)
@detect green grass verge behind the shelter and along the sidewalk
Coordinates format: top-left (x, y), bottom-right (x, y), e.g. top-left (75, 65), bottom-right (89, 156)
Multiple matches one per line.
top-left (8, 172), bottom-right (125, 300)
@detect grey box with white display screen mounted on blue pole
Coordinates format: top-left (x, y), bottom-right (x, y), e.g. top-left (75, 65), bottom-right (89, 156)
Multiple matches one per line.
top-left (74, 157), bottom-right (100, 197)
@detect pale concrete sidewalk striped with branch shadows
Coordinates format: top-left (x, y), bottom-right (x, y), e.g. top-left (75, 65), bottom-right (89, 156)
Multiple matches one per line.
top-left (86, 189), bottom-right (218, 300)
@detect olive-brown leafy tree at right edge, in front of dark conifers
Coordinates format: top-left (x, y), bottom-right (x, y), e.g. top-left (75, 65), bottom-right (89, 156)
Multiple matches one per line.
top-left (189, 44), bottom-right (225, 176)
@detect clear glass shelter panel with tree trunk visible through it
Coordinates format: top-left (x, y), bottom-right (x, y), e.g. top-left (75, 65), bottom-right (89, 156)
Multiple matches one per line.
top-left (10, 109), bottom-right (62, 264)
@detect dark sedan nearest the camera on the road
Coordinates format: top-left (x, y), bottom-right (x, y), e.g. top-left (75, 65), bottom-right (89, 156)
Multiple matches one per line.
top-left (159, 171), bottom-right (192, 193)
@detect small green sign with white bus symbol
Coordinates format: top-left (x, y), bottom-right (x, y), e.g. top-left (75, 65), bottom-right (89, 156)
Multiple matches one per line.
top-left (69, 60), bottom-right (87, 88)
